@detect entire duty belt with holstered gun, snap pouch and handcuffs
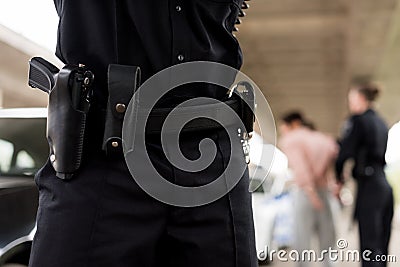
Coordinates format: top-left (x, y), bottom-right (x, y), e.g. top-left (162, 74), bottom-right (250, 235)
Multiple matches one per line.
top-left (29, 58), bottom-right (254, 179)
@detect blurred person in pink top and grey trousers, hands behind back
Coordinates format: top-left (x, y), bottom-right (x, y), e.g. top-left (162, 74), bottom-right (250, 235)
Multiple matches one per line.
top-left (279, 112), bottom-right (338, 267)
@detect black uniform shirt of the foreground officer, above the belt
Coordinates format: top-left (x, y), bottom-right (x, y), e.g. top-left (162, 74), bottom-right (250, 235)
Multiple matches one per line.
top-left (54, 0), bottom-right (243, 106)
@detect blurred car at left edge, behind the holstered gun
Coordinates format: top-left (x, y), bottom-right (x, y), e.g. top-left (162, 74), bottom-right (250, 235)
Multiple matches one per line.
top-left (0, 108), bottom-right (49, 267)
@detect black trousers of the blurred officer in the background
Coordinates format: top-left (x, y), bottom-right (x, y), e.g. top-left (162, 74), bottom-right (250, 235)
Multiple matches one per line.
top-left (356, 172), bottom-right (394, 267)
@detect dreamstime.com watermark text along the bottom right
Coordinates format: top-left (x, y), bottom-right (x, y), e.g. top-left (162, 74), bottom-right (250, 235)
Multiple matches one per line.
top-left (257, 239), bottom-right (397, 262)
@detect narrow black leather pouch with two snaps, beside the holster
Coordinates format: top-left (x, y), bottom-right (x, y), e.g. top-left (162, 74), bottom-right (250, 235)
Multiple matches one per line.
top-left (103, 64), bottom-right (140, 155)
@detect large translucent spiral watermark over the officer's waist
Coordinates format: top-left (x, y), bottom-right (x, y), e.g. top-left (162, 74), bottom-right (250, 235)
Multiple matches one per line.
top-left (122, 62), bottom-right (276, 207)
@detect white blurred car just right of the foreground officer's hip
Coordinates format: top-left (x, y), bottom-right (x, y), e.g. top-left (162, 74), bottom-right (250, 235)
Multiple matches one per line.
top-left (249, 135), bottom-right (293, 263)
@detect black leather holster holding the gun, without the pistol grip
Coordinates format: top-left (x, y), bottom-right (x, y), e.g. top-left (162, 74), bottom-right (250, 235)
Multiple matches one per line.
top-left (47, 67), bottom-right (87, 179)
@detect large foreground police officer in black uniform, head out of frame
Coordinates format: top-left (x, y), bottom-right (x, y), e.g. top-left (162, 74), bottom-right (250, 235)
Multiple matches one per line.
top-left (30, 0), bottom-right (257, 267)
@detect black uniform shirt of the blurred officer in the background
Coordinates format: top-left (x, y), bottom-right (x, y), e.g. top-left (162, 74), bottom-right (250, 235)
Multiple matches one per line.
top-left (336, 109), bottom-right (388, 181)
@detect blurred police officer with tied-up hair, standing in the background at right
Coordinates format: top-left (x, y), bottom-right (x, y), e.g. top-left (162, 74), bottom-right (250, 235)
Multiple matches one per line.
top-left (336, 85), bottom-right (393, 267)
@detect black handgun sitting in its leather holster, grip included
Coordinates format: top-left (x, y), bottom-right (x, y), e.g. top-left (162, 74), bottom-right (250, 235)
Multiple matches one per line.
top-left (28, 57), bottom-right (94, 179)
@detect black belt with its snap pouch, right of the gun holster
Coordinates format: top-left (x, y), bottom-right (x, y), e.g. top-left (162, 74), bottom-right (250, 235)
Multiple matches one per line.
top-left (103, 64), bottom-right (254, 155)
